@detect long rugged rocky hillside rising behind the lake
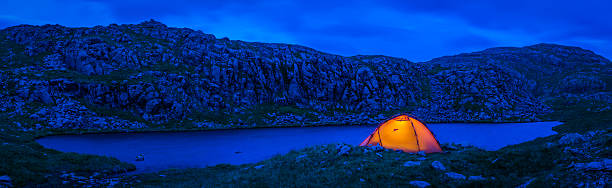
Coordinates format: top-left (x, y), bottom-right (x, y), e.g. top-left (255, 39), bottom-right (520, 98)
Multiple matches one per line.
top-left (0, 20), bottom-right (612, 129)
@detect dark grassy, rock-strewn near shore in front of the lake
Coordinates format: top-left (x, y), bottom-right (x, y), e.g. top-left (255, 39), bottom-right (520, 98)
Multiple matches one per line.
top-left (0, 101), bottom-right (612, 187)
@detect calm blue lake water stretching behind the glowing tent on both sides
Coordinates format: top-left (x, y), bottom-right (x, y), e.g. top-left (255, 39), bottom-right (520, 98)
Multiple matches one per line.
top-left (37, 122), bottom-right (561, 173)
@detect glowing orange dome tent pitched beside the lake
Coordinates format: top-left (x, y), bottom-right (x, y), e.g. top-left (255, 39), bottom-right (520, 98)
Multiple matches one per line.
top-left (359, 115), bottom-right (442, 153)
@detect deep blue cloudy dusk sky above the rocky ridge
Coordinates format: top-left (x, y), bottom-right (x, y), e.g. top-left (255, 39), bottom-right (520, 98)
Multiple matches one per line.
top-left (0, 0), bottom-right (612, 62)
